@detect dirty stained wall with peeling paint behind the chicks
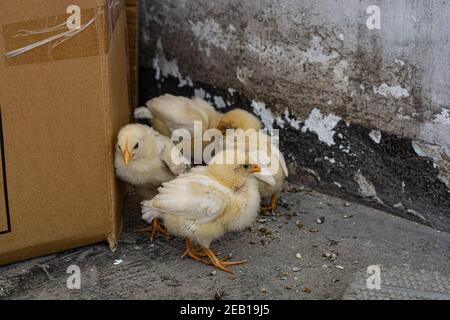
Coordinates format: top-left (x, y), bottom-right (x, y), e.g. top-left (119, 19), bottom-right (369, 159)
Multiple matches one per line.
top-left (140, 0), bottom-right (450, 231)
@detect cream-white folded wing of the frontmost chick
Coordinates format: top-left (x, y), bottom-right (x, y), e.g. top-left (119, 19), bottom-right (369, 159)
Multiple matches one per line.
top-left (151, 174), bottom-right (232, 224)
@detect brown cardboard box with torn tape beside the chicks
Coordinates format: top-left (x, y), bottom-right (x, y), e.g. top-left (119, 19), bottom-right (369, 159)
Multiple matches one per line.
top-left (0, 0), bottom-right (129, 264)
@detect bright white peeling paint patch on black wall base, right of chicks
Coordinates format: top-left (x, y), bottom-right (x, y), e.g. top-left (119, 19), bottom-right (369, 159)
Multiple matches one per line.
top-left (302, 108), bottom-right (342, 146)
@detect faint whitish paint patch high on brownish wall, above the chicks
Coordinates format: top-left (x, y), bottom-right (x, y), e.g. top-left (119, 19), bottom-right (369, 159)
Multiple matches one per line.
top-left (189, 18), bottom-right (236, 57)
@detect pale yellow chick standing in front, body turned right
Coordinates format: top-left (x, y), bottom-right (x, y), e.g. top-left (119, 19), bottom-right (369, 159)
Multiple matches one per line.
top-left (142, 149), bottom-right (261, 273)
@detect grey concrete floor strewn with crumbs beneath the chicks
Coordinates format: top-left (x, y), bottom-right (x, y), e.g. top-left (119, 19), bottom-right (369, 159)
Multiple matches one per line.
top-left (0, 184), bottom-right (450, 299)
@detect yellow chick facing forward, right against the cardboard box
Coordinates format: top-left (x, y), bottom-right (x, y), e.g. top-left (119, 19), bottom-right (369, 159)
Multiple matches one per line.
top-left (114, 124), bottom-right (188, 239)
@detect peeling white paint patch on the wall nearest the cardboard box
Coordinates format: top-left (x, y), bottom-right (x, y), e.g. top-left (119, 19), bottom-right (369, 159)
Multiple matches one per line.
top-left (153, 39), bottom-right (193, 87)
